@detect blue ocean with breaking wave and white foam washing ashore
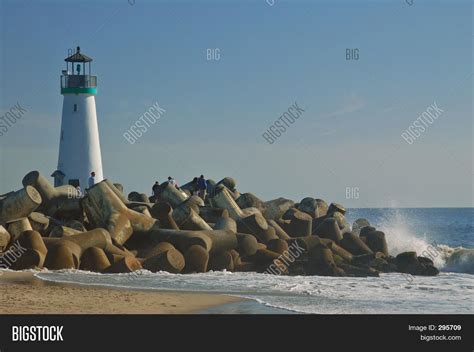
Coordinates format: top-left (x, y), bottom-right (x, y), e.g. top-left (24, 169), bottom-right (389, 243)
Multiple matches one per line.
top-left (36, 208), bottom-right (474, 314)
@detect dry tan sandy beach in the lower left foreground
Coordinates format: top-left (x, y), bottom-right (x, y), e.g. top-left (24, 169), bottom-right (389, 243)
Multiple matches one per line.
top-left (0, 272), bottom-right (241, 314)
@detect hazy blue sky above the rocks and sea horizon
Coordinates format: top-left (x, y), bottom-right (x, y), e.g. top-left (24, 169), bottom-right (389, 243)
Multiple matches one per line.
top-left (0, 0), bottom-right (474, 207)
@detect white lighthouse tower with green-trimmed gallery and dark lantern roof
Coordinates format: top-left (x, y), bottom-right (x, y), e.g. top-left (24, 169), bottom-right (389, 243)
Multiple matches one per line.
top-left (51, 47), bottom-right (103, 190)
